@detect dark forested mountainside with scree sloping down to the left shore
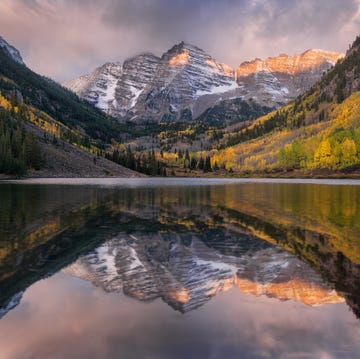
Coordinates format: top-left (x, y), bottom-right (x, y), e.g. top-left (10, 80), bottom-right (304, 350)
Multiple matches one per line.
top-left (0, 38), bottom-right (139, 177)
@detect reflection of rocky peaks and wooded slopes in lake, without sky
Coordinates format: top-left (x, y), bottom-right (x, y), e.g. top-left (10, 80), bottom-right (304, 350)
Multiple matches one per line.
top-left (0, 184), bottom-right (360, 314)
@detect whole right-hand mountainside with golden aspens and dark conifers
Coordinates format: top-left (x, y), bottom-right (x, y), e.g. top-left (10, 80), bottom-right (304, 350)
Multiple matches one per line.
top-left (212, 37), bottom-right (360, 176)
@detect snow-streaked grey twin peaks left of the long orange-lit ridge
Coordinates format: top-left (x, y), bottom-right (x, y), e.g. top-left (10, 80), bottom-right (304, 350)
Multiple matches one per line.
top-left (64, 42), bottom-right (237, 121)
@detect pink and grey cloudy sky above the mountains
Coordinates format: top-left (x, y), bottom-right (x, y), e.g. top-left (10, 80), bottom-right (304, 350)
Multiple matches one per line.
top-left (0, 0), bottom-right (360, 82)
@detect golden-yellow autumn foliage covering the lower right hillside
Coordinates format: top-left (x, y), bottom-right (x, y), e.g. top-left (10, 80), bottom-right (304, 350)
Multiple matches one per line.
top-left (212, 91), bottom-right (360, 171)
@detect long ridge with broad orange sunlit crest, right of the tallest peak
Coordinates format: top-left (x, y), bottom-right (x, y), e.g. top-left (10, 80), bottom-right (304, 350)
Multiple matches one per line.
top-left (236, 50), bottom-right (344, 106)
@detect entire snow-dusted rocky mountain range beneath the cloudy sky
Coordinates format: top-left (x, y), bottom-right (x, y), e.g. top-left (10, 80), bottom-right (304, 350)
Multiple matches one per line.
top-left (64, 42), bottom-right (342, 122)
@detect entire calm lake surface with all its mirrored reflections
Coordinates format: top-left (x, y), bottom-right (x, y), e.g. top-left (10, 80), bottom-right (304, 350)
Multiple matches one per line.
top-left (0, 178), bottom-right (360, 359)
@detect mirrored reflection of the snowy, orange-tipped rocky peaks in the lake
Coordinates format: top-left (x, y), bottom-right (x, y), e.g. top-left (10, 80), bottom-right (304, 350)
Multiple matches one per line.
top-left (64, 233), bottom-right (343, 312)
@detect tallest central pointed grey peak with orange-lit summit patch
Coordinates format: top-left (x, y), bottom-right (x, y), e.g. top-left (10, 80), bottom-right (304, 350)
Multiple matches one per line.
top-left (134, 42), bottom-right (237, 121)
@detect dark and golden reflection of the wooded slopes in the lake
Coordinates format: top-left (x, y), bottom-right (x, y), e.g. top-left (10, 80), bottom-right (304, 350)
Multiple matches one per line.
top-left (0, 184), bottom-right (360, 315)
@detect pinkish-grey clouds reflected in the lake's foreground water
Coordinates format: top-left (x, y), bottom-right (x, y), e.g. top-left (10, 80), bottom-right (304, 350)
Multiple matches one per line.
top-left (0, 274), bottom-right (360, 359)
